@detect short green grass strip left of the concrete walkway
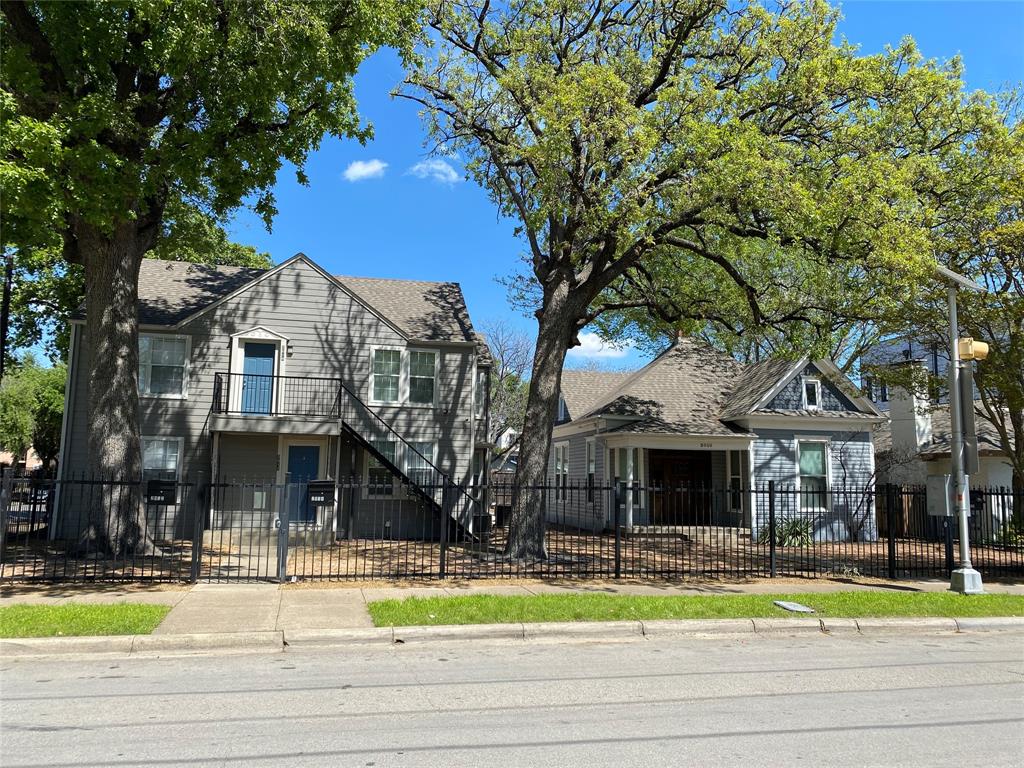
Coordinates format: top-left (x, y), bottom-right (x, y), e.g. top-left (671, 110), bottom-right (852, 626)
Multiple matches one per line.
top-left (0, 603), bottom-right (171, 637)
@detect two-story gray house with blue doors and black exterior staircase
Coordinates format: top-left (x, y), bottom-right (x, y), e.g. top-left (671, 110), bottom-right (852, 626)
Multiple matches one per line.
top-left (60, 254), bottom-right (490, 538)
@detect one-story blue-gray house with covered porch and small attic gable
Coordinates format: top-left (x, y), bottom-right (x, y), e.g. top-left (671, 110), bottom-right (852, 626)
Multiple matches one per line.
top-left (549, 339), bottom-right (885, 540)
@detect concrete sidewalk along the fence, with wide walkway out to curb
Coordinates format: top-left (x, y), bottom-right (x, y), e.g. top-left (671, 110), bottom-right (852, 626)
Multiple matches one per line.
top-left (0, 579), bottom-right (1024, 635)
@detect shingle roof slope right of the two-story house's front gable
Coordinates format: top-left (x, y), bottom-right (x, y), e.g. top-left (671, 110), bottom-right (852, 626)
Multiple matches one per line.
top-left (336, 275), bottom-right (477, 343)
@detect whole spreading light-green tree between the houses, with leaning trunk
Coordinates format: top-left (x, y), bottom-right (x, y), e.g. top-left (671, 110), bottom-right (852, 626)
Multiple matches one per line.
top-left (402, 0), bottom-right (1011, 557)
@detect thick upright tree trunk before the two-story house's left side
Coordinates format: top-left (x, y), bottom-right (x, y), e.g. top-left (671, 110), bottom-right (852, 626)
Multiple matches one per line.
top-left (75, 221), bottom-right (153, 555)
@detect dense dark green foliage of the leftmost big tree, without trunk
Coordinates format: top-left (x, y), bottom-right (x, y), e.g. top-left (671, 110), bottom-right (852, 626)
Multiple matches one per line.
top-left (0, 0), bottom-right (419, 366)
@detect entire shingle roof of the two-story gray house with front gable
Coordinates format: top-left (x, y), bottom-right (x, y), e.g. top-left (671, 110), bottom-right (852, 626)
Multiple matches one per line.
top-left (73, 259), bottom-right (477, 344)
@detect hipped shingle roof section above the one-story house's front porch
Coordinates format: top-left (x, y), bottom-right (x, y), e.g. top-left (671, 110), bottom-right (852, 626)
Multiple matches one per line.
top-left (587, 339), bottom-right (742, 435)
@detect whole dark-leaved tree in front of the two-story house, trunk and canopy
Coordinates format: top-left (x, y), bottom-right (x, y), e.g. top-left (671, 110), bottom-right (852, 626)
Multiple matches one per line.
top-left (0, 0), bottom-right (419, 551)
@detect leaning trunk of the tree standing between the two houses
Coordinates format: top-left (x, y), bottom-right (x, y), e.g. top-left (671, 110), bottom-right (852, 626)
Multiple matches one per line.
top-left (505, 284), bottom-right (580, 559)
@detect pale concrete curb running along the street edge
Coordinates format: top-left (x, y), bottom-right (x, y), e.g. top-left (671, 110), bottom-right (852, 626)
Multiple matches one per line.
top-left (0, 616), bottom-right (1024, 658)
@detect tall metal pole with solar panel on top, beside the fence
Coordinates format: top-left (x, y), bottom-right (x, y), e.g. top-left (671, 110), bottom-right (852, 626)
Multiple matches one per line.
top-left (938, 266), bottom-right (984, 595)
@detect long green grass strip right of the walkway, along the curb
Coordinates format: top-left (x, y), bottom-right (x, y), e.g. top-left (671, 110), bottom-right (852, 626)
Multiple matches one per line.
top-left (369, 592), bottom-right (1024, 627)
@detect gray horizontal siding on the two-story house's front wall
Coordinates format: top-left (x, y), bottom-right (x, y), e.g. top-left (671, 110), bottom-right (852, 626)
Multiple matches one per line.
top-left (61, 260), bottom-right (477, 536)
